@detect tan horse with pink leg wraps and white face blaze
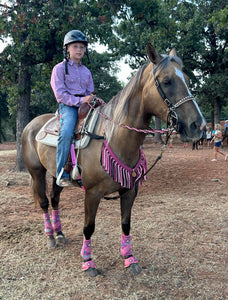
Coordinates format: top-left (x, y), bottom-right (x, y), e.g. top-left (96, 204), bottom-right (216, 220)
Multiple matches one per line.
top-left (22, 43), bottom-right (205, 277)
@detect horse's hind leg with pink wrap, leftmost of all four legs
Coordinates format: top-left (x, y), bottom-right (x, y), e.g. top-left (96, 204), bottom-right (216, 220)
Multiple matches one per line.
top-left (28, 166), bottom-right (56, 248)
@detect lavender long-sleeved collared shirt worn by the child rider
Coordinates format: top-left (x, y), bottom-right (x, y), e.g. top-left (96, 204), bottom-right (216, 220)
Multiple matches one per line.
top-left (51, 59), bottom-right (94, 107)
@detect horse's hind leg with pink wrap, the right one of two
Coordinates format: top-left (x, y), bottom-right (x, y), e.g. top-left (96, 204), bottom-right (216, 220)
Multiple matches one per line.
top-left (50, 177), bottom-right (66, 246)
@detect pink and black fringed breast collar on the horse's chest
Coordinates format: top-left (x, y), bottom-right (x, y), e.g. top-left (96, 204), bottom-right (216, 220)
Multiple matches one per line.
top-left (101, 140), bottom-right (147, 189)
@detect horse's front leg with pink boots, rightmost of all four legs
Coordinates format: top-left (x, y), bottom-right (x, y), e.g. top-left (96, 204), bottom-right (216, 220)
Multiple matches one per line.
top-left (120, 190), bottom-right (141, 275)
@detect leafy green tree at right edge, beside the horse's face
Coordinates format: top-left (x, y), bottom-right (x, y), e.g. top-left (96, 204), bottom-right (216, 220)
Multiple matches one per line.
top-left (170, 0), bottom-right (228, 123)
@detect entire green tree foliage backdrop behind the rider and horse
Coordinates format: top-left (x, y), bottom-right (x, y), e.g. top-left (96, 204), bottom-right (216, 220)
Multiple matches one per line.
top-left (0, 0), bottom-right (228, 142)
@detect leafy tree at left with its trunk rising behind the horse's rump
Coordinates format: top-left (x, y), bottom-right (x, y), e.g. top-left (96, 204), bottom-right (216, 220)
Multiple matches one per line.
top-left (0, 0), bottom-right (120, 171)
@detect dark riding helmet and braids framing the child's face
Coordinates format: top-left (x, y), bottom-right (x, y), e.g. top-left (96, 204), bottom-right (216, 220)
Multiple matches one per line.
top-left (63, 30), bottom-right (90, 74)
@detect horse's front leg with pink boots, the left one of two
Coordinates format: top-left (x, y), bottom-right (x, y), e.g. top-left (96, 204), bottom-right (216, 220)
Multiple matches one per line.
top-left (81, 191), bottom-right (100, 277)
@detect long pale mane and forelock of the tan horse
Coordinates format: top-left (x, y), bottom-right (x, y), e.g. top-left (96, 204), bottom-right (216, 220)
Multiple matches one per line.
top-left (102, 55), bottom-right (182, 142)
